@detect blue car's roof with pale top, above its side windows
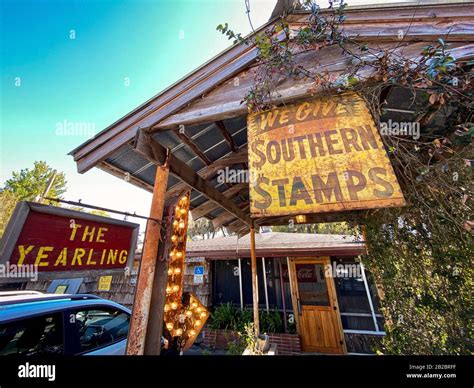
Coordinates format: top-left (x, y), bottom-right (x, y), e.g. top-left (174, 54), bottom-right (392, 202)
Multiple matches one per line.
top-left (0, 292), bottom-right (130, 323)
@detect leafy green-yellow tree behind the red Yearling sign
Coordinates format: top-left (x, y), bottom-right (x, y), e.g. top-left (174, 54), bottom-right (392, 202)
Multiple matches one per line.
top-left (0, 161), bottom-right (66, 237)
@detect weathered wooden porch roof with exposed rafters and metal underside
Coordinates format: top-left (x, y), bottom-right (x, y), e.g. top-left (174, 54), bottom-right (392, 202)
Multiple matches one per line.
top-left (70, 2), bottom-right (474, 233)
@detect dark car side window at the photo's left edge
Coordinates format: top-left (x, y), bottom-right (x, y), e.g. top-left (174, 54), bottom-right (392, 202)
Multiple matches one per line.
top-left (0, 313), bottom-right (64, 356)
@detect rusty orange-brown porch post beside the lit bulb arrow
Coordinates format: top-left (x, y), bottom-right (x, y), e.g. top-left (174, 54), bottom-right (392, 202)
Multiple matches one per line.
top-left (127, 154), bottom-right (169, 355)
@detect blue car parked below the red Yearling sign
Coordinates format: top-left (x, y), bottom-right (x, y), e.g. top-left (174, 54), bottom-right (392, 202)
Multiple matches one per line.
top-left (0, 291), bottom-right (130, 356)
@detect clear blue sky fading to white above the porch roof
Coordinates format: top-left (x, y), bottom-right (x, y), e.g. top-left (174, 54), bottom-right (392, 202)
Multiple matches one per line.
top-left (0, 0), bottom-right (408, 230)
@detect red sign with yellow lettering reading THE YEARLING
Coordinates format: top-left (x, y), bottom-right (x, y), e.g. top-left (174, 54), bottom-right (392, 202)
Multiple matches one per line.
top-left (0, 202), bottom-right (139, 280)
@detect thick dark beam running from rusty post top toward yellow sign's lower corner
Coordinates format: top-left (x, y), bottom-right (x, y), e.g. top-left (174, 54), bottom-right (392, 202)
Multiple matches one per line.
top-left (135, 131), bottom-right (251, 225)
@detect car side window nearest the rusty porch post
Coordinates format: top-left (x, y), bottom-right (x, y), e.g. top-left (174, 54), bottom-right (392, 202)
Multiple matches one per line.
top-left (75, 308), bottom-right (130, 352)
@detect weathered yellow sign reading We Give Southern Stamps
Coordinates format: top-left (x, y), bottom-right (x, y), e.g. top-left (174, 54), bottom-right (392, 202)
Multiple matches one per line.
top-left (248, 93), bottom-right (405, 217)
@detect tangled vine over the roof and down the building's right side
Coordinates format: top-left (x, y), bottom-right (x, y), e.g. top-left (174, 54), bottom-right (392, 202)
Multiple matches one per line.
top-left (218, 1), bottom-right (474, 354)
